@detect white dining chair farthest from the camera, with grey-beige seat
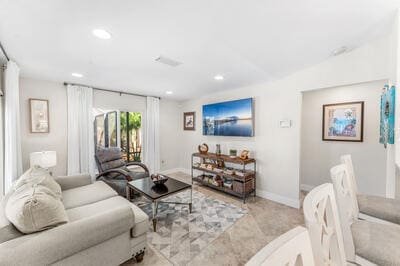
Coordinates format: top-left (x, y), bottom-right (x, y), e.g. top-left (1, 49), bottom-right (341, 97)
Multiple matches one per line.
top-left (340, 154), bottom-right (400, 224)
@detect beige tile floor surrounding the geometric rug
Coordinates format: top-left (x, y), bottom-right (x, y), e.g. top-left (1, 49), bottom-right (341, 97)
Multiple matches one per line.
top-left (123, 172), bottom-right (304, 266)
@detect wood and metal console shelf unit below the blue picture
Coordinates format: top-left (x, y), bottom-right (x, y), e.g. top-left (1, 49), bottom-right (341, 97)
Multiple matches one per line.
top-left (191, 153), bottom-right (256, 203)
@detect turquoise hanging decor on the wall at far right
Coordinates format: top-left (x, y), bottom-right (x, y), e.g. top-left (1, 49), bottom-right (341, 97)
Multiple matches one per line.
top-left (379, 85), bottom-right (396, 148)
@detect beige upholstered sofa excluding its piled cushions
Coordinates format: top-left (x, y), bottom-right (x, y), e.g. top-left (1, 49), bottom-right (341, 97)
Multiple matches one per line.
top-left (0, 175), bottom-right (149, 266)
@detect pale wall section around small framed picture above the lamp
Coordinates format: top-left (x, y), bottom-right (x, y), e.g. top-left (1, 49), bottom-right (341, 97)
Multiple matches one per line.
top-left (20, 78), bottom-right (67, 175)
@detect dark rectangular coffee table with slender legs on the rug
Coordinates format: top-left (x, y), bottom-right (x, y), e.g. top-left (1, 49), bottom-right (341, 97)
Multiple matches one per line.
top-left (126, 177), bottom-right (192, 232)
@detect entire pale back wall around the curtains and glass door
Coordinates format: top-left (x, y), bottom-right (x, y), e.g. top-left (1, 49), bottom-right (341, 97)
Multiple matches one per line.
top-left (20, 78), bottom-right (179, 175)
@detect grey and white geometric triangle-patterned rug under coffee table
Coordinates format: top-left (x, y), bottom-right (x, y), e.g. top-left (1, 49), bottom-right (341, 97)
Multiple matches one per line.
top-left (141, 190), bottom-right (247, 265)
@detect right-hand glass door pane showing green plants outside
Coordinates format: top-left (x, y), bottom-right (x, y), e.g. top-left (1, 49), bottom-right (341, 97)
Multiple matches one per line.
top-left (120, 112), bottom-right (142, 162)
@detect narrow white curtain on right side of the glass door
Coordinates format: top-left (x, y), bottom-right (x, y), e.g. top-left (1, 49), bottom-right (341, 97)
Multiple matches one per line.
top-left (144, 97), bottom-right (160, 174)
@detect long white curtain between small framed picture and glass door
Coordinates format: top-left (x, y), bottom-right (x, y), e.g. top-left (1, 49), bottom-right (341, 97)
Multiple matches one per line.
top-left (67, 85), bottom-right (95, 177)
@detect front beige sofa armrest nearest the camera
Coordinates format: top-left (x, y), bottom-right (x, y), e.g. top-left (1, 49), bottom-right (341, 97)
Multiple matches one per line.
top-left (0, 206), bottom-right (135, 265)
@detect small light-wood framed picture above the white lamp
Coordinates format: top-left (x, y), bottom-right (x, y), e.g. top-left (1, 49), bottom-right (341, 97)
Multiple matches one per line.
top-left (29, 99), bottom-right (50, 133)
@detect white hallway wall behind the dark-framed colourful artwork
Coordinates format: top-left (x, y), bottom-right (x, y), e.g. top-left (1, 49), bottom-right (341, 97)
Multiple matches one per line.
top-left (301, 80), bottom-right (388, 196)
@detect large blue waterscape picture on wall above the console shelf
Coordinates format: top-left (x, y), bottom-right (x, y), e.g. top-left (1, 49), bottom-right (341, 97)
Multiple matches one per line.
top-left (203, 98), bottom-right (254, 137)
